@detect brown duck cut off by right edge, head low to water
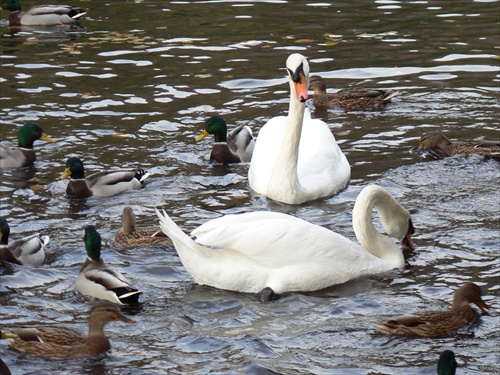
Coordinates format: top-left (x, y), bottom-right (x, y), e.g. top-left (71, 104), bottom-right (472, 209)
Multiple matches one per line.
top-left (418, 132), bottom-right (500, 159)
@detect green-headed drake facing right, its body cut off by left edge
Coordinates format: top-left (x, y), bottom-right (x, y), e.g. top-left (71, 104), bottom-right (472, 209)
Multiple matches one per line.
top-left (0, 123), bottom-right (55, 168)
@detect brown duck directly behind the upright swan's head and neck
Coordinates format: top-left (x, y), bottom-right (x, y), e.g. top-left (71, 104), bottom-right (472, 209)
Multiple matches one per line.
top-left (309, 76), bottom-right (399, 110)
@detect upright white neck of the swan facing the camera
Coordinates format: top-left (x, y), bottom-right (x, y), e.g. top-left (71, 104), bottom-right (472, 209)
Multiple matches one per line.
top-left (267, 80), bottom-right (305, 203)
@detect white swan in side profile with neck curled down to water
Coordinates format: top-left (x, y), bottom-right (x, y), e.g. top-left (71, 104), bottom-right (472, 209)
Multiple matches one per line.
top-left (156, 185), bottom-right (414, 298)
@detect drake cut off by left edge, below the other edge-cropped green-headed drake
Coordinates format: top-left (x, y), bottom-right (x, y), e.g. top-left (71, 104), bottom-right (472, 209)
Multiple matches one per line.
top-left (0, 216), bottom-right (50, 267)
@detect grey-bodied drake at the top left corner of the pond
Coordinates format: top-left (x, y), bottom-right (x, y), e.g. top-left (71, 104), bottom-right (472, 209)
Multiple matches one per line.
top-left (0, 0), bottom-right (86, 26)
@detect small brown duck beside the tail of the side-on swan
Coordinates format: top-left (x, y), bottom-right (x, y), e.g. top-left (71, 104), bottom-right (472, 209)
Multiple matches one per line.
top-left (115, 207), bottom-right (172, 247)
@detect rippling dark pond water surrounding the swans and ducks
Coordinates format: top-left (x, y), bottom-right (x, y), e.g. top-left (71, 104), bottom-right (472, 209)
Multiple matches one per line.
top-left (0, 0), bottom-right (500, 374)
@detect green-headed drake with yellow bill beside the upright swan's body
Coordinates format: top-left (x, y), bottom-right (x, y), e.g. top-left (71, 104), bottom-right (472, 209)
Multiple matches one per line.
top-left (196, 116), bottom-right (255, 163)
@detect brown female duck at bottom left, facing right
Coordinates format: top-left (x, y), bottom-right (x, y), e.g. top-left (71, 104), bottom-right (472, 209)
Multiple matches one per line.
top-left (2, 302), bottom-right (135, 360)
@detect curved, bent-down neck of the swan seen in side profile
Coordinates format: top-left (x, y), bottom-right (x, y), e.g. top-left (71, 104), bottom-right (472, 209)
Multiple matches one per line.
top-left (352, 185), bottom-right (408, 268)
